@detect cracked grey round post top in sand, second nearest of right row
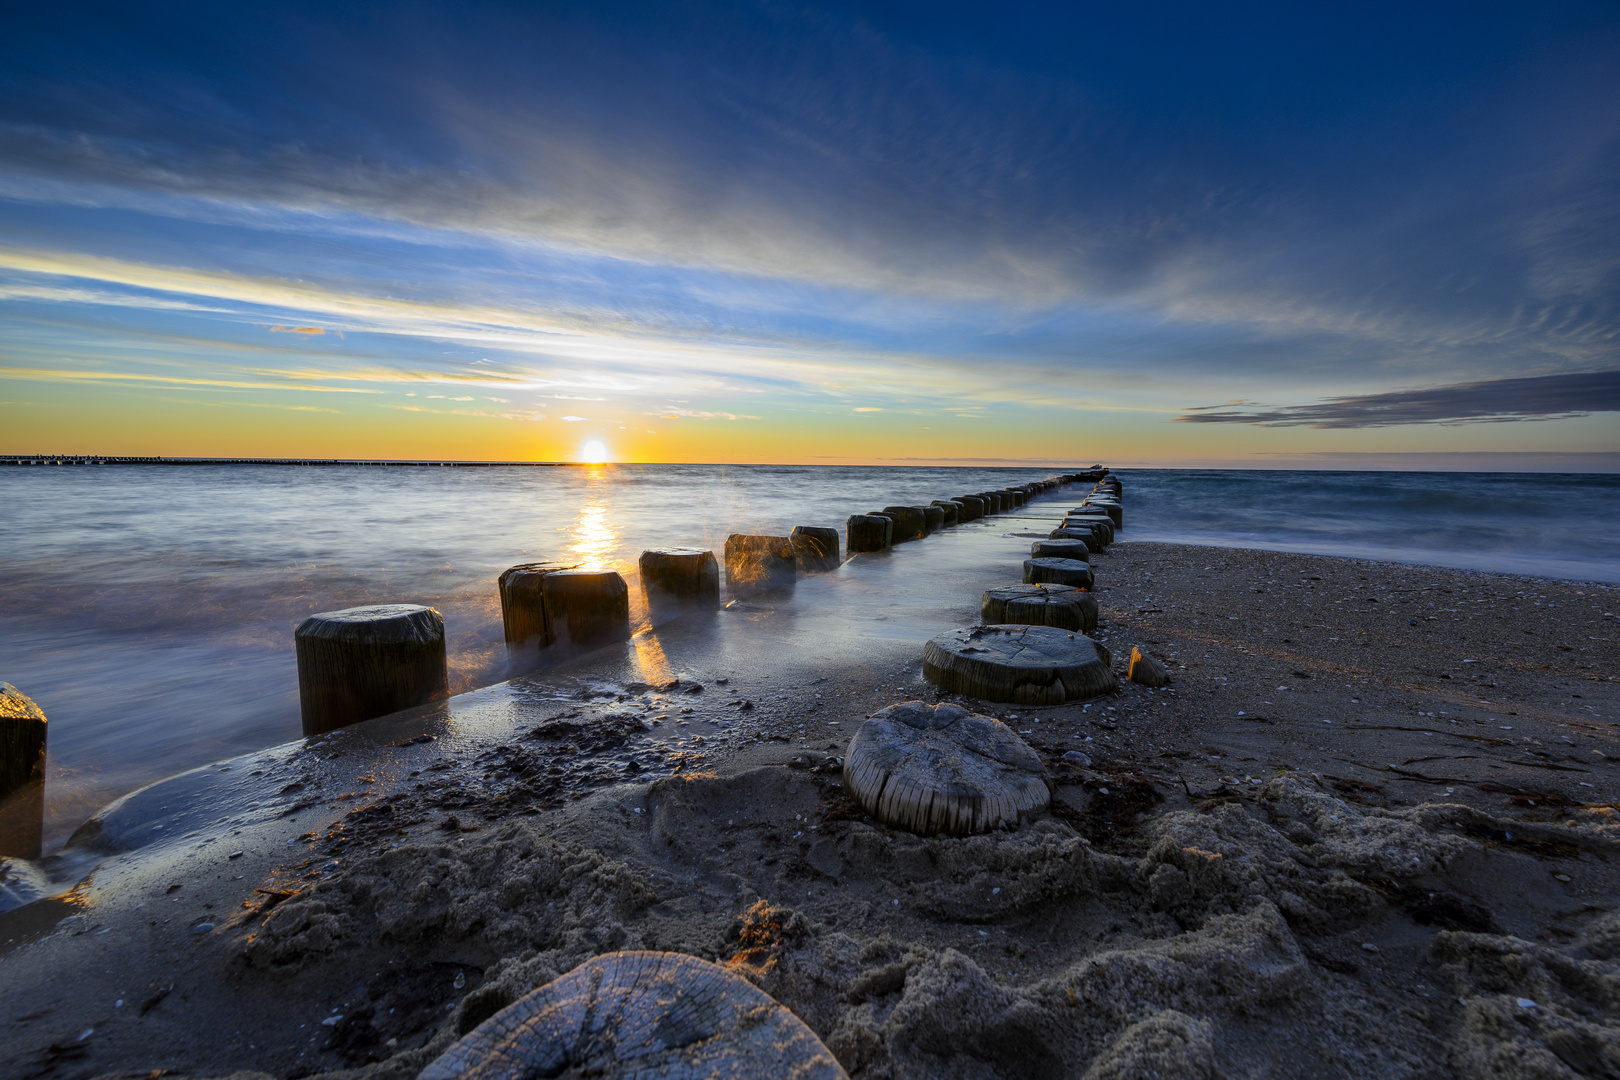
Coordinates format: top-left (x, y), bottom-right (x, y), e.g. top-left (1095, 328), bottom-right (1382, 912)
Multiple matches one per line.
top-left (844, 701), bottom-right (1051, 836)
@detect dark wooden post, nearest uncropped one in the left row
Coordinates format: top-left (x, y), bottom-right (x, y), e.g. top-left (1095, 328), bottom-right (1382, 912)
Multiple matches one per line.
top-left (293, 604), bottom-right (450, 735)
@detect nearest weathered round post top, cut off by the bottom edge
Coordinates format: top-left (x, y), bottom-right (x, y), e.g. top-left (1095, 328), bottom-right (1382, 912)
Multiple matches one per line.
top-left (418, 952), bottom-right (849, 1080)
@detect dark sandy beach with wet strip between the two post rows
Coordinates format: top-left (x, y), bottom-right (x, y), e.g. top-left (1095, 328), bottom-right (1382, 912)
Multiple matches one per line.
top-left (0, 501), bottom-right (1620, 1080)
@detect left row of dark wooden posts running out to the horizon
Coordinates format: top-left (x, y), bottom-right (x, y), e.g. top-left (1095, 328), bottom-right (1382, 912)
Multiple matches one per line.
top-left (0, 468), bottom-right (1118, 858)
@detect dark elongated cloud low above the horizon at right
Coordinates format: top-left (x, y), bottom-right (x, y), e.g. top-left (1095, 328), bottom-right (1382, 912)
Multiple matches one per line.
top-left (1176, 371), bottom-right (1620, 427)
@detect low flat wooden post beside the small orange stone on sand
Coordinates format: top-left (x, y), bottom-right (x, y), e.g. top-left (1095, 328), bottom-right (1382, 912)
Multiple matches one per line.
top-left (922, 625), bottom-right (1119, 704)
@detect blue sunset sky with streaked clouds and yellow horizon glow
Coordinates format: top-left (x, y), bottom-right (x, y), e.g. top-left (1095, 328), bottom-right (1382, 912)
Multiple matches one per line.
top-left (0, 0), bottom-right (1620, 470)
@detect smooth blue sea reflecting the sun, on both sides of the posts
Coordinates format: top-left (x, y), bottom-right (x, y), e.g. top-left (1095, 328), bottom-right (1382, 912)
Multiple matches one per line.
top-left (0, 465), bottom-right (1620, 850)
